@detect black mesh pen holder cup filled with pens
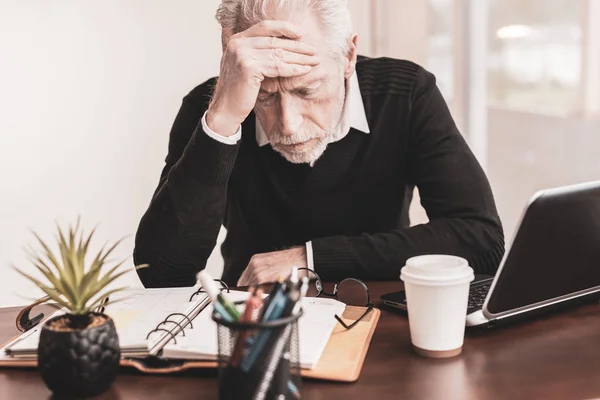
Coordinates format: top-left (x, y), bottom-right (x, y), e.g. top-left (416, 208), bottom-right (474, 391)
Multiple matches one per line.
top-left (212, 302), bottom-right (302, 400)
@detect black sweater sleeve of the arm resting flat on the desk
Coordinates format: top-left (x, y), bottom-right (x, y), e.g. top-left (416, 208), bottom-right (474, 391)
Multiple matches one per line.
top-left (312, 69), bottom-right (504, 279)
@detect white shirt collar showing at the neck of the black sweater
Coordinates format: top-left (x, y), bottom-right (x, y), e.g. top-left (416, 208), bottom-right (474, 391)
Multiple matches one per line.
top-left (256, 72), bottom-right (370, 147)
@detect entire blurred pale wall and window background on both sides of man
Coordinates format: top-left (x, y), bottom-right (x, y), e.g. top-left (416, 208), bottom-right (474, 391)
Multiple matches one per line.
top-left (0, 0), bottom-right (600, 306)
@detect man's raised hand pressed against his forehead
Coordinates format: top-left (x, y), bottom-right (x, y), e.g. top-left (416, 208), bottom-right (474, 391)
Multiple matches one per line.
top-left (206, 21), bottom-right (319, 136)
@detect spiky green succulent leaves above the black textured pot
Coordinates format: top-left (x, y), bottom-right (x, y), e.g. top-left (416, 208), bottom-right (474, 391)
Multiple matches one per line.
top-left (15, 218), bottom-right (147, 316)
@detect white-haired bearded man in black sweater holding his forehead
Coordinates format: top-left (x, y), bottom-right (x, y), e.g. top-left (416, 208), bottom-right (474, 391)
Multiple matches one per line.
top-left (134, 0), bottom-right (504, 287)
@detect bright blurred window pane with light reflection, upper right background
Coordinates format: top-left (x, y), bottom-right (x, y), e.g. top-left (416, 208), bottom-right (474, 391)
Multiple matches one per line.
top-left (487, 0), bottom-right (583, 115)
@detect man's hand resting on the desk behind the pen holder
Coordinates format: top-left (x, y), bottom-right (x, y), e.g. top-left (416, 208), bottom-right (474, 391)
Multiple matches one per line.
top-left (238, 246), bottom-right (308, 286)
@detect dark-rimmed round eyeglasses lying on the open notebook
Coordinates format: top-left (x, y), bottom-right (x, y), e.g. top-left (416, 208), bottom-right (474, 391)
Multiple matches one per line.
top-left (298, 268), bottom-right (375, 329)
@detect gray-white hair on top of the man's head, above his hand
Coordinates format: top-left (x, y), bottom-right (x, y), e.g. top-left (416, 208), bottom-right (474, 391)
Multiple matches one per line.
top-left (216, 0), bottom-right (352, 55)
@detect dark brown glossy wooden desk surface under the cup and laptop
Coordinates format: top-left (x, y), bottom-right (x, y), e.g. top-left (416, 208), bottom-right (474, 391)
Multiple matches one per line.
top-left (0, 282), bottom-right (600, 400)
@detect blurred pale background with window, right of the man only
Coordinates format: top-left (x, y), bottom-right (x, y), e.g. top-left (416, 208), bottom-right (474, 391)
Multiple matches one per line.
top-left (384, 0), bottom-right (600, 241)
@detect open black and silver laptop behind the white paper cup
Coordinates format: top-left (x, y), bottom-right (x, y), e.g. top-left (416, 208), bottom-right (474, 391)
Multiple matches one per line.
top-left (381, 181), bottom-right (600, 328)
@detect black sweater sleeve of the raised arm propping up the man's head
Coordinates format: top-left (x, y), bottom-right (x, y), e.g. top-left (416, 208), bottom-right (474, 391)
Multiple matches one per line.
top-left (134, 83), bottom-right (241, 287)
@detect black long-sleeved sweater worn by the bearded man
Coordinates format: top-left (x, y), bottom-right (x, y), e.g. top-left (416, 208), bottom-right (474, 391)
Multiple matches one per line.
top-left (134, 57), bottom-right (504, 287)
